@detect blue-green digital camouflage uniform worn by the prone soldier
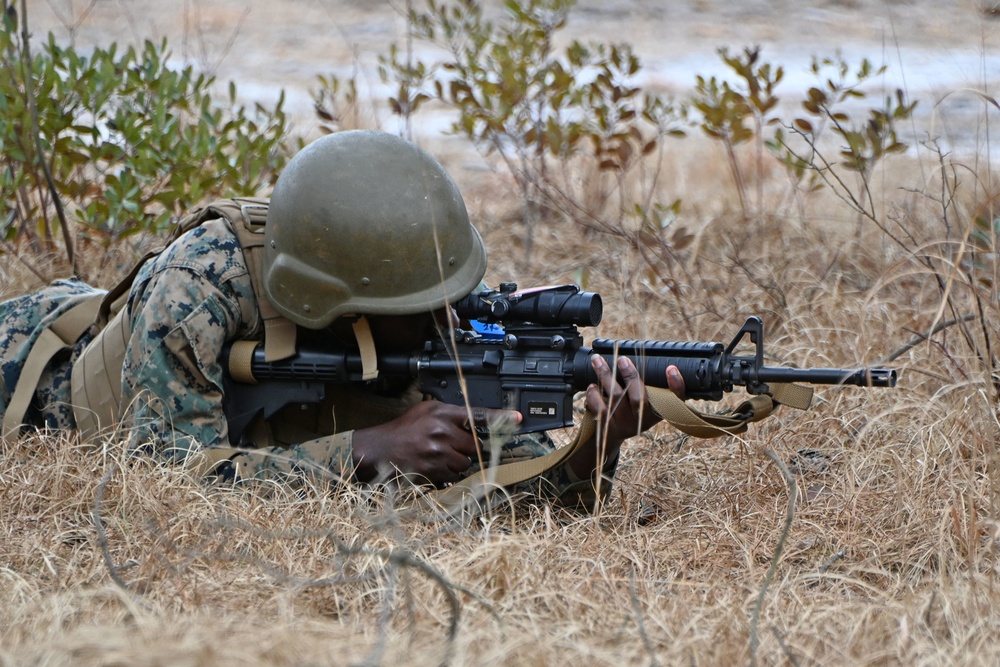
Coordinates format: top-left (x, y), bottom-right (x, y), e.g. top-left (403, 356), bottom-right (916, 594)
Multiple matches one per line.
top-left (0, 220), bottom-right (615, 505)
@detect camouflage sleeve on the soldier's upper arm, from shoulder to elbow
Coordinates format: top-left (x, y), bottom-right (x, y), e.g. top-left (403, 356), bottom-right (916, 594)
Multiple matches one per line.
top-left (122, 220), bottom-right (259, 461)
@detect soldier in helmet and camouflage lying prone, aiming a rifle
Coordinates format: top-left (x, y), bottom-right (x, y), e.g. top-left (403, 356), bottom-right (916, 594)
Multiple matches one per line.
top-left (0, 131), bottom-right (684, 507)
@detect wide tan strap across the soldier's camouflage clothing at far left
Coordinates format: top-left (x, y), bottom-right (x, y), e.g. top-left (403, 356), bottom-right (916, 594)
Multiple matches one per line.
top-left (0, 292), bottom-right (104, 440)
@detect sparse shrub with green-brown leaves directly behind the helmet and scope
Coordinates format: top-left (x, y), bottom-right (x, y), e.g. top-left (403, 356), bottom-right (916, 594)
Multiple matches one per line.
top-left (379, 0), bottom-right (686, 262)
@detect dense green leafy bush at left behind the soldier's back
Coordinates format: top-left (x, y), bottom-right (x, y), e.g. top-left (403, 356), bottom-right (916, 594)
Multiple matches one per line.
top-left (0, 6), bottom-right (290, 270)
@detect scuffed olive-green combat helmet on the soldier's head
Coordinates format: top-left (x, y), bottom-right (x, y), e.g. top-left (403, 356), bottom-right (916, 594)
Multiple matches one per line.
top-left (264, 130), bottom-right (486, 329)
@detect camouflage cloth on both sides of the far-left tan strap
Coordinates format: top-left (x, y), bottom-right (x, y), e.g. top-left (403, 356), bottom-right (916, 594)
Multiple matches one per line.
top-left (0, 278), bottom-right (104, 429)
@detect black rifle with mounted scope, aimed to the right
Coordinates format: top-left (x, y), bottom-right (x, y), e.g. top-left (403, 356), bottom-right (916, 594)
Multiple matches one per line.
top-left (223, 283), bottom-right (896, 443)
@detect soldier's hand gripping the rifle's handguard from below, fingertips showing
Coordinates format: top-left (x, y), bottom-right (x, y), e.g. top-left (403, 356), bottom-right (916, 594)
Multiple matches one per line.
top-left (586, 355), bottom-right (684, 445)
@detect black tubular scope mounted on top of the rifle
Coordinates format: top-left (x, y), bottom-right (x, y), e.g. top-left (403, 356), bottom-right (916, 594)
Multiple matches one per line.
top-left (455, 283), bottom-right (604, 327)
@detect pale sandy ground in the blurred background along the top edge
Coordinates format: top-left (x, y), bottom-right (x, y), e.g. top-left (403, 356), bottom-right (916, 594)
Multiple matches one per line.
top-left (19, 0), bottom-right (1000, 151)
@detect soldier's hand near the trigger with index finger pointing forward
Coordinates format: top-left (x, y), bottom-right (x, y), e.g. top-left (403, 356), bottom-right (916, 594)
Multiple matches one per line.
top-left (352, 401), bottom-right (521, 484)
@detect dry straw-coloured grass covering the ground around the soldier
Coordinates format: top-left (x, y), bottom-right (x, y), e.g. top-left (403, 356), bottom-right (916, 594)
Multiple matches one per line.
top-left (0, 126), bottom-right (1000, 665)
